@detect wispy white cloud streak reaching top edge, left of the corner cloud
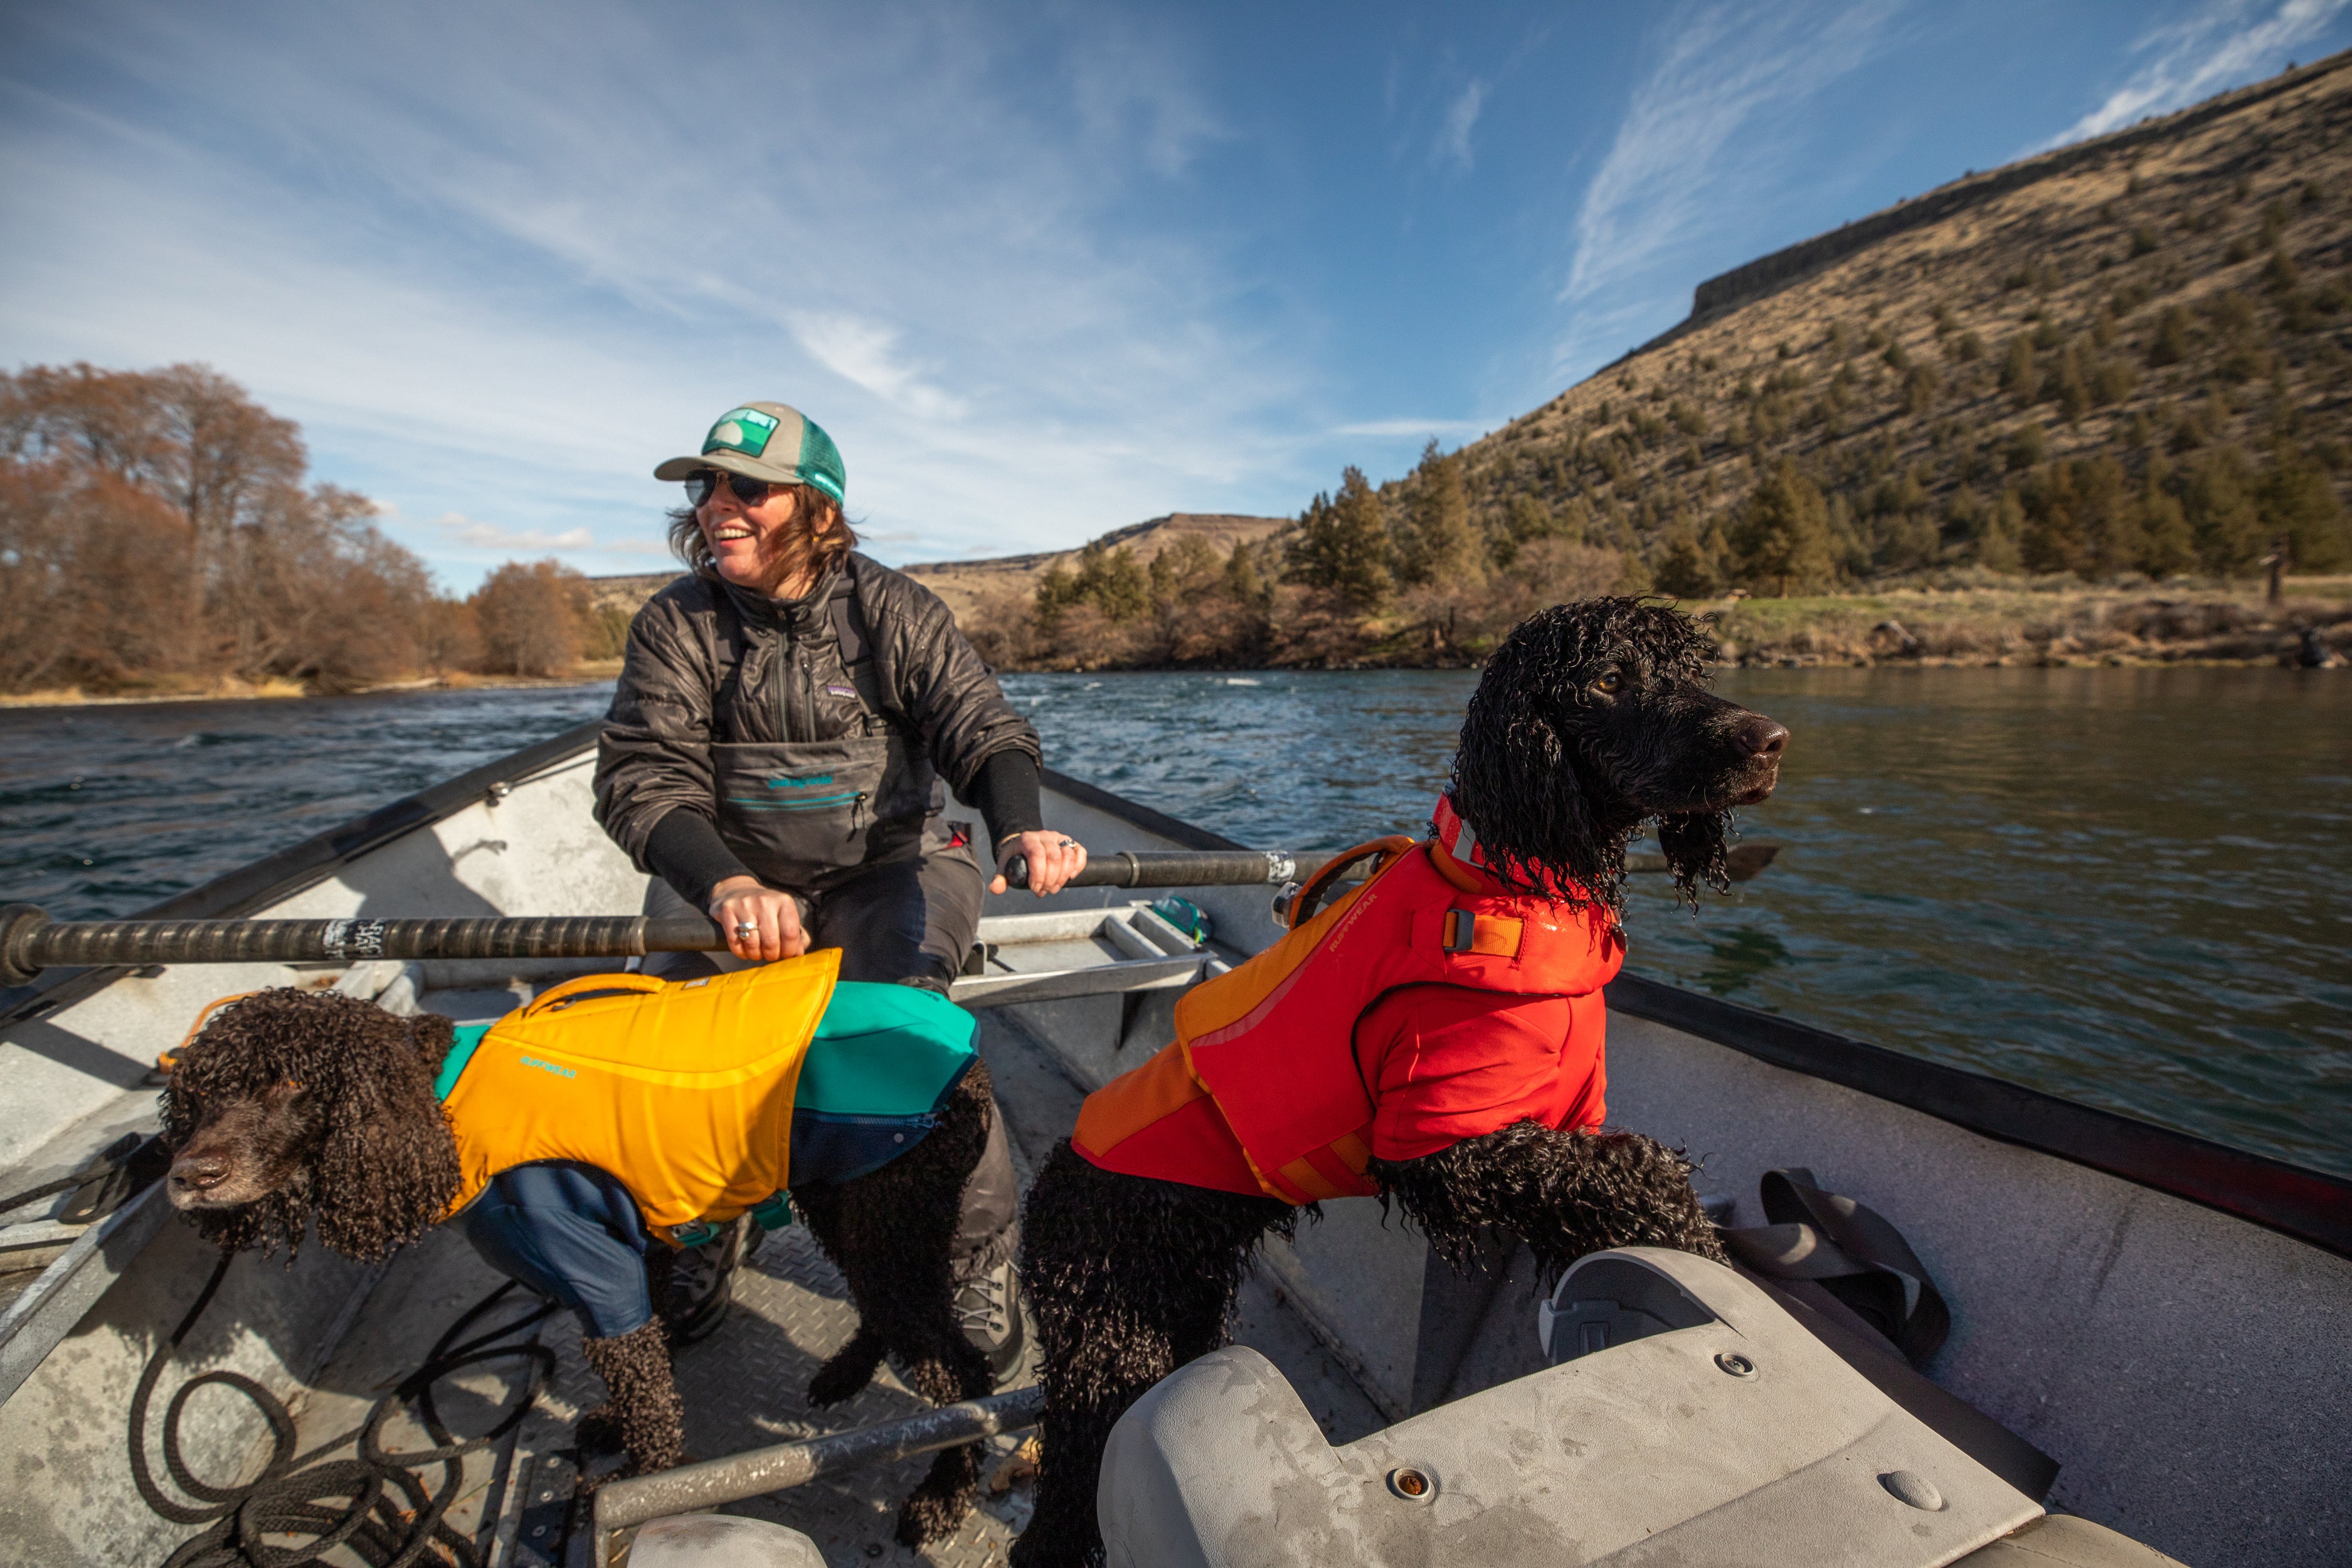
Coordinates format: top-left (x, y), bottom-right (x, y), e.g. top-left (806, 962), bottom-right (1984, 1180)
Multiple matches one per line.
top-left (1557, 0), bottom-right (1894, 373)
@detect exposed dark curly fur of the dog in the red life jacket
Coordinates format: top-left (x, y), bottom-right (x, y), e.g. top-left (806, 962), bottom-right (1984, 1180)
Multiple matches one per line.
top-left (1014, 597), bottom-right (1788, 1568)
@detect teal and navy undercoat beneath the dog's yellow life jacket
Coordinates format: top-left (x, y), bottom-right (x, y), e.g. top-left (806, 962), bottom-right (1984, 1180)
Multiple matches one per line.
top-left (435, 980), bottom-right (969, 1338)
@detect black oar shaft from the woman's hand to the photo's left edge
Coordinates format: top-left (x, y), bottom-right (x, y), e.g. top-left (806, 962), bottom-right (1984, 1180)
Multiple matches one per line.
top-left (0, 903), bottom-right (727, 985)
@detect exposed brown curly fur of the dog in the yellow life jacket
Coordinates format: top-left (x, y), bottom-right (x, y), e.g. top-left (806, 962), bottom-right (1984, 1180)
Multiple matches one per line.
top-left (162, 990), bottom-right (993, 1545)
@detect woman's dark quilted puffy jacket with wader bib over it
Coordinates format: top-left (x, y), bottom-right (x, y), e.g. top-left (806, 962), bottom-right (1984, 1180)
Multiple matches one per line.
top-left (595, 553), bottom-right (1042, 886)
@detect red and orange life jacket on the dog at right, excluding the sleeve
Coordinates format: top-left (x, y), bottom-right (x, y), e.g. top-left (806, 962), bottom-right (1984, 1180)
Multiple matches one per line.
top-left (1070, 799), bottom-right (1625, 1204)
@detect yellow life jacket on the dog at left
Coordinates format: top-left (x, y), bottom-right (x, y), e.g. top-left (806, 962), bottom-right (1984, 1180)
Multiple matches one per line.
top-left (442, 947), bottom-right (842, 1234)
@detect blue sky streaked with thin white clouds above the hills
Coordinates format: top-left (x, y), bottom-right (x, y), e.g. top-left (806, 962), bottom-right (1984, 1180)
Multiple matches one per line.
top-left (0, 0), bottom-right (2352, 590)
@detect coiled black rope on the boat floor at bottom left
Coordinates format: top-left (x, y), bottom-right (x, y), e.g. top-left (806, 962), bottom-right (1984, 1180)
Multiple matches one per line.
top-left (129, 1253), bottom-right (555, 1568)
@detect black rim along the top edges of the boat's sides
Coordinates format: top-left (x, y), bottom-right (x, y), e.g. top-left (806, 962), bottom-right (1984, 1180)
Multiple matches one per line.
top-left (0, 719), bottom-right (2352, 1258)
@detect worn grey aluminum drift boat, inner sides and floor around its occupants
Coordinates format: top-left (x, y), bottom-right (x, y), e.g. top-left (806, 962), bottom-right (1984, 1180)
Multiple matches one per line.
top-left (0, 726), bottom-right (2352, 1568)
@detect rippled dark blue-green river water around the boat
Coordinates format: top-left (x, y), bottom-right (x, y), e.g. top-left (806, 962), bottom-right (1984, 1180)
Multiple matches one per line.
top-left (0, 670), bottom-right (2352, 1175)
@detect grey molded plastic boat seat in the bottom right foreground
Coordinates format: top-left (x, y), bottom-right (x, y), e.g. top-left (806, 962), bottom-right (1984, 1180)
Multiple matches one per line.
top-left (1096, 1248), bottom-right (2042, 1568)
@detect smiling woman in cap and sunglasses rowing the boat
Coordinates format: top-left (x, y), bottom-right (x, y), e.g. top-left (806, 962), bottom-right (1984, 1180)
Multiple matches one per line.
top-left (595, 402), bottom-right (1087, 1394)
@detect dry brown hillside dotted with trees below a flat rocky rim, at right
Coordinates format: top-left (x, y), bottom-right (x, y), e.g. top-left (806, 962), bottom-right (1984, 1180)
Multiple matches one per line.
top-left (1430, 56), bottom-right (2352, 595)
